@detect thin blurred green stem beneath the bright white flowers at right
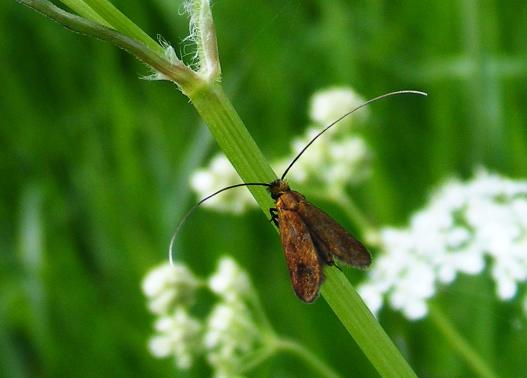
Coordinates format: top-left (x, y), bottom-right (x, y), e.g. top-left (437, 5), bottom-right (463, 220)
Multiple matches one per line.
top-left (429, 305), bottom-right (498, 378)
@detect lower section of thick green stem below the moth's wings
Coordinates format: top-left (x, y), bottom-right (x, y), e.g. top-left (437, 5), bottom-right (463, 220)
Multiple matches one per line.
top-left (322, 267), bottom-right (416, 378)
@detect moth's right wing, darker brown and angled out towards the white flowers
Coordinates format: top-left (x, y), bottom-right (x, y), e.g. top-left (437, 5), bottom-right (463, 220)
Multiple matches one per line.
top-left (297, 196), bottom-right (371, 268)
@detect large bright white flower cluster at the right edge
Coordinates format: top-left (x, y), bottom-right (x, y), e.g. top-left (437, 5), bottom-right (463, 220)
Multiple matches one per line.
top-left (359, 171), bottom-right (527, 319)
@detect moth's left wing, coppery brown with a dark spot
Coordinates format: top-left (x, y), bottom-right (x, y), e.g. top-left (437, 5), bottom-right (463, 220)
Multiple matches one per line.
top-left (278, 209), bottom-right (324, 303)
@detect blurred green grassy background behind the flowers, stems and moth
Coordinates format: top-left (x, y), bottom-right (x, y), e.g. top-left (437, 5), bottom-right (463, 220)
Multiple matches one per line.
top-left (0, 0), bottom-right (527, 377)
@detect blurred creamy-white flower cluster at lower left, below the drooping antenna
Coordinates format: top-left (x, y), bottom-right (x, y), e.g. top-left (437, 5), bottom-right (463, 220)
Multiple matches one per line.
top-left (143, 257), bottom-right (273, 377)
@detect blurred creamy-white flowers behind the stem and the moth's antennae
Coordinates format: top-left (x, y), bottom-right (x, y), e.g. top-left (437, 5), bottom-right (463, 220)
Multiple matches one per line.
top-left (191, 87), bottom-right (371, 214)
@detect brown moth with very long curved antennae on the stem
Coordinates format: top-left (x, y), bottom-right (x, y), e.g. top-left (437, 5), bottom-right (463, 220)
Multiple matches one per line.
top-left (169, 90), bottom-right (426, 303)
